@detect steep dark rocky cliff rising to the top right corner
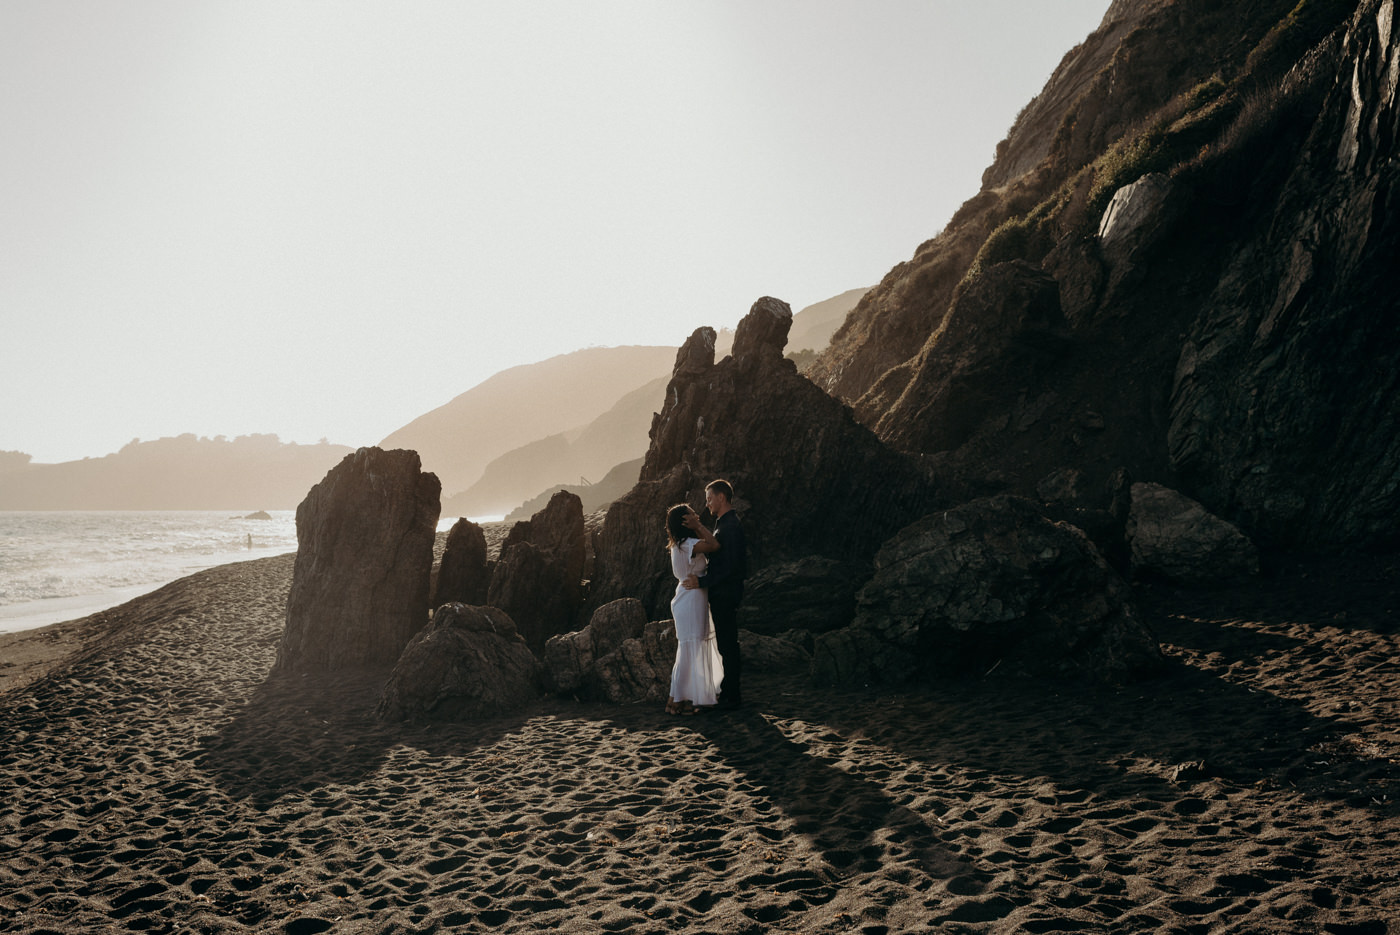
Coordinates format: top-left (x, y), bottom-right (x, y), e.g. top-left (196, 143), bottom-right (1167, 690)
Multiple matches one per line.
top-left (808, 0), bottom-right (1400, 547)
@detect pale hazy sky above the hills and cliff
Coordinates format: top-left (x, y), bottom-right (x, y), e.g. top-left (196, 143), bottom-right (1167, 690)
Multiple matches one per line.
top-left (0, 0), bottom-right (1109, 462)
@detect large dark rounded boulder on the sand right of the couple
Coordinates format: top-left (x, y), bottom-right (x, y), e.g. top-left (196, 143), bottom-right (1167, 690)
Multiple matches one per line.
top-left (813, 495), bottom-right (1161, 683)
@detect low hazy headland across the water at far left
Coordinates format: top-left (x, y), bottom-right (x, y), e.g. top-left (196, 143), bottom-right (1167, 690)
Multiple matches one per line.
top-left (0, 435), bottom-right (351, 509)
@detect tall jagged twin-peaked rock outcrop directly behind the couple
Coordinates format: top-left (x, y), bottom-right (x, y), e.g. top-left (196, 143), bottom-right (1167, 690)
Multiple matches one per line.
top-left (592, 298), bottom-right (934, 617)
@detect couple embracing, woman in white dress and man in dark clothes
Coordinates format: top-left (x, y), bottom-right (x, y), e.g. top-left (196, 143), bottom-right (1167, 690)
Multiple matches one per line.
top-left (666, 480), bottom-right (748, 714)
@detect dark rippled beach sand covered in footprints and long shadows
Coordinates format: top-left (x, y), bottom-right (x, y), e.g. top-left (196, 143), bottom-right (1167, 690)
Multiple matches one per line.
top-left (0, 556), bottom-right (1400, 935)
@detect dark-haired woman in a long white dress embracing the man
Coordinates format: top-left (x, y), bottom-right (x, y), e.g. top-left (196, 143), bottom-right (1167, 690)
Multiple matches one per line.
top-left (666, 504), bottom-right (724, 714)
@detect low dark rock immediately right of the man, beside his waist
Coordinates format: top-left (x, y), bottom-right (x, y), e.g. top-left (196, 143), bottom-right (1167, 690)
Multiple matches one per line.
top-left (739, 556), bottom-right (871, 635)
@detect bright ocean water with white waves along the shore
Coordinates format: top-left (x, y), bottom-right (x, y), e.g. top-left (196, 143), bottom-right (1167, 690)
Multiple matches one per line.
top-left (0, 509), bottom-right (297, 633)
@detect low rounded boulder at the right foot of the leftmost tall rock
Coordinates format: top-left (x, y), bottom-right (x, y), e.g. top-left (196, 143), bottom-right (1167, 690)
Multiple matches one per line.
top-left (375, 603), bottom-right (540, 721)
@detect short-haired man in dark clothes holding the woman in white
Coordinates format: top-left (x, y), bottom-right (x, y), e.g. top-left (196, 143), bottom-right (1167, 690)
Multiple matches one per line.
top-left (682, 480), bottom-right (749, 710)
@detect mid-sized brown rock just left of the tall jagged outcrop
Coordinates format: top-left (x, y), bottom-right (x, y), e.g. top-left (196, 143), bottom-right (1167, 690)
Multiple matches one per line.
top-left (486, 491), bottom-right (587, 654)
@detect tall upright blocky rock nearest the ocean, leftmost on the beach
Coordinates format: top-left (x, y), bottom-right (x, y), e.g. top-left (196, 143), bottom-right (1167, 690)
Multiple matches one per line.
top-left (276, 448), bottom-right (441, 670)
